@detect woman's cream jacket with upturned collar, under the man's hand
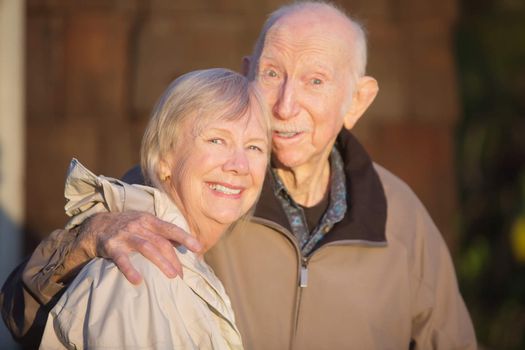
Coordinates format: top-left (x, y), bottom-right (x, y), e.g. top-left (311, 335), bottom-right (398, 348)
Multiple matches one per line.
top-left (40, 160), bottom-right (242, 349)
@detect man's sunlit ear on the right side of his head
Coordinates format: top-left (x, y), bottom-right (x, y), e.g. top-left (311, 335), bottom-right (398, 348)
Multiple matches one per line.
top-left (344, 76), bottom-right (379, 130)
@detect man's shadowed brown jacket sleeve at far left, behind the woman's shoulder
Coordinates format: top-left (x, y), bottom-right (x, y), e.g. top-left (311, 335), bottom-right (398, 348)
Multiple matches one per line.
top-left (0, 230), bottom-right (75, 348)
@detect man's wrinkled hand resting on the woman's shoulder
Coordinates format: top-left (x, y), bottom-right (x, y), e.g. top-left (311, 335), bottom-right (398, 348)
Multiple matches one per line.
top-left (70, 211), bottom-right (201, 284)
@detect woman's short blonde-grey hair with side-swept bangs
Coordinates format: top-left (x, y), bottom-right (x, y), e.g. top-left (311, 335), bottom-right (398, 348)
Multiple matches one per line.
top-left (141, 68), bottom-right (271, 191)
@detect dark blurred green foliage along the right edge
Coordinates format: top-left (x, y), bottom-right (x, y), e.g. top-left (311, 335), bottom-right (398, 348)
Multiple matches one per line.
top-left (455, 0), bottom-right (525, 349)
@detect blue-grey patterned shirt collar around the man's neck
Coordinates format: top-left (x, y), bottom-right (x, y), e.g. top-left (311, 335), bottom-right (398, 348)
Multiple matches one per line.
top-left (272, 147), bottom-right (346, 257)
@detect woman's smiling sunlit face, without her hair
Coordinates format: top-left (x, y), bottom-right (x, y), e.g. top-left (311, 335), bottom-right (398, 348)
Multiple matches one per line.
top-left (163, 108), bottom-right (270, 238)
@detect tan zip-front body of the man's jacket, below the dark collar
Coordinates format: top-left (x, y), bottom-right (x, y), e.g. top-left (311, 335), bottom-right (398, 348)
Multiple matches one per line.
top-left (207, 166), bottom-right (477, 350)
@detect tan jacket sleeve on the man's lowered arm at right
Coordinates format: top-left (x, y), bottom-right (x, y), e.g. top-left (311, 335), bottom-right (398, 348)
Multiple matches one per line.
top-left (411, 205), bottom-right (477, 350)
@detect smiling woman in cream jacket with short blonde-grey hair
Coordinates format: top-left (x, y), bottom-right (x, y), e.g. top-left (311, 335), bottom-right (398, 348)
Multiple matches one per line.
top-left (40, 69), bottom-right (270, 349)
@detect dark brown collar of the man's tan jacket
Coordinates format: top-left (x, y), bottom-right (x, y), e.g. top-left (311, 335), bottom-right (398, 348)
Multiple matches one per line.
top-left (254, 129), bottom-right (387, 249)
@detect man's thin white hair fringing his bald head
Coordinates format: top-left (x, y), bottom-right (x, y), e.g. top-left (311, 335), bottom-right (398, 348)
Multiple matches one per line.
top-left (248, 0), bottom-right (367, 81)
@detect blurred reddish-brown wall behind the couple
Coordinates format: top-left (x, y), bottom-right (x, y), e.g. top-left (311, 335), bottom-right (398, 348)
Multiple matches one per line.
top-left (25, 0), bottom-right (459, 249)
